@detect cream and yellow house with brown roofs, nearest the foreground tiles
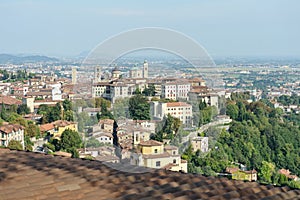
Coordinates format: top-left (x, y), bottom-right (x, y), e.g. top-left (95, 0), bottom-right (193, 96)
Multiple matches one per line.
top-left (130, 140), bottom-right (187, 172)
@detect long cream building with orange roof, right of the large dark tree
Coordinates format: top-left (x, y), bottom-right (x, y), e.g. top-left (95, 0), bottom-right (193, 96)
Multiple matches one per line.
top-left (150, 101), bottom-right (193, 125)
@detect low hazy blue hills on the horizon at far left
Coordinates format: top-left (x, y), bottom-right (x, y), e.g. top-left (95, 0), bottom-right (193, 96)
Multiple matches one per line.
top-left (0, 54), bottom-right (59, 64)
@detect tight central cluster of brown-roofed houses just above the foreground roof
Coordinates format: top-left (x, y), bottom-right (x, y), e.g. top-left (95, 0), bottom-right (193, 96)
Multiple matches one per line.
top-left (82, 119), bottom-right (187, 172)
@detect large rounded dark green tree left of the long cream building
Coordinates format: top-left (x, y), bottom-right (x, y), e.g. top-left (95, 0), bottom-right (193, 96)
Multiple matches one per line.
top-left (129, 94), bottom-right (150, 120)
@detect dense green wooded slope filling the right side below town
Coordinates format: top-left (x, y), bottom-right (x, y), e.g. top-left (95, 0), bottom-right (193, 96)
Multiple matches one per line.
top-left (183, 94), bottom-right (300, 188)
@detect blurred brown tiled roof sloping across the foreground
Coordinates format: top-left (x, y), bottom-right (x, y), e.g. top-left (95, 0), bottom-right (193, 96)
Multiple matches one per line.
top-left (0, 149), bottom-right (300, 200)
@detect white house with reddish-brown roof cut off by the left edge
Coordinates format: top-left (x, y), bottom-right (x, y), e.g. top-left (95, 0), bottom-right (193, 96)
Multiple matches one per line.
top-left (0, 124), bottom-right (24, 149)
